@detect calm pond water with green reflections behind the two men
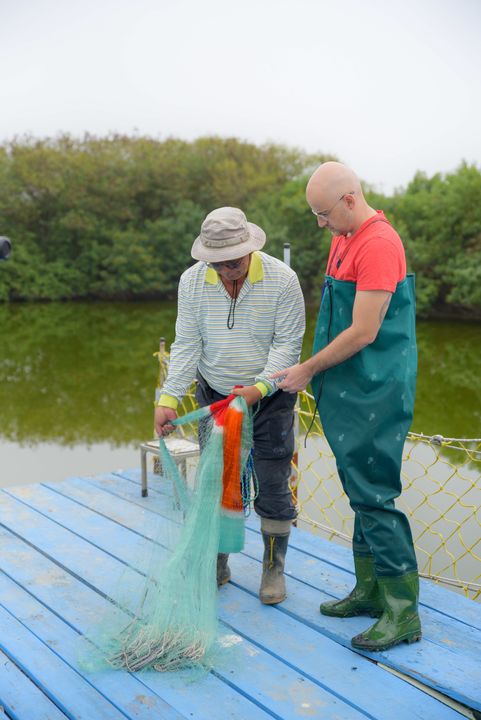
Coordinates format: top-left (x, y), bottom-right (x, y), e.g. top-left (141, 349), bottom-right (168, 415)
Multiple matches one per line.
top-left (0, 302), bottom-right (481, 582)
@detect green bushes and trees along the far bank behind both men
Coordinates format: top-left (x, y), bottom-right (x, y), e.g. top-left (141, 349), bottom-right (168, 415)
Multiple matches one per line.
top-left (0, 136), bottom-right (481, 317)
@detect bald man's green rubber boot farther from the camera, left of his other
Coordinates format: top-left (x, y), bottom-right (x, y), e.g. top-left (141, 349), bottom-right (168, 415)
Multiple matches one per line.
top-left (319, 555), bottom-right (384, 617)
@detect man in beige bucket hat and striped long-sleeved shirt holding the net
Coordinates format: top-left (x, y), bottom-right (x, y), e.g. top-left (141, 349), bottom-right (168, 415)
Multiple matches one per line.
top-left (155, 207), bottom-right (305, 604)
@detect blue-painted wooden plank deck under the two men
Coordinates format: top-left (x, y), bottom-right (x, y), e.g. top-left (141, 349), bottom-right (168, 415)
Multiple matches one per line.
top-left (0, 471), bottom-right (481, 720)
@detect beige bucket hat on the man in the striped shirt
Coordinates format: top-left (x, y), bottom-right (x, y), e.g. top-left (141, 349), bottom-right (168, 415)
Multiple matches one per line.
top-left (191, 207), bottom-right (266, 262)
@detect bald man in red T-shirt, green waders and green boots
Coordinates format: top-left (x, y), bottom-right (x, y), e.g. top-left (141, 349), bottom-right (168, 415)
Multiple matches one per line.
top-left (272, 162), bottom-right (421, 651)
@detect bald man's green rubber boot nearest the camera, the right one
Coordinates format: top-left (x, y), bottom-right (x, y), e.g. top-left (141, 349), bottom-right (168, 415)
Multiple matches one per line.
top-left (351, 571), bottom-right (421, 652)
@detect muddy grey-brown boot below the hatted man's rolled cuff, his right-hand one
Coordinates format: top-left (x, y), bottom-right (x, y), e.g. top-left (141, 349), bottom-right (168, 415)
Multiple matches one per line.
top-left (259, 518), bottom-right (292, 605)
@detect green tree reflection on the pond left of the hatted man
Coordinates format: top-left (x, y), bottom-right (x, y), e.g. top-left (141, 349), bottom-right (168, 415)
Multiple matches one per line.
top-left (0, 296), bottom-right (175, 446)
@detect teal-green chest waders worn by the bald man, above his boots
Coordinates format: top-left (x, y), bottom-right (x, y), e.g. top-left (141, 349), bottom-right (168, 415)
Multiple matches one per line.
top-left (311, 275), bottom-right (417, 576)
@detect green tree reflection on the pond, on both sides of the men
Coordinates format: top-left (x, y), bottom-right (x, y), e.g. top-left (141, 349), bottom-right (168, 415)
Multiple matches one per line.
top-left (0, 302), bottom-right (481, 446)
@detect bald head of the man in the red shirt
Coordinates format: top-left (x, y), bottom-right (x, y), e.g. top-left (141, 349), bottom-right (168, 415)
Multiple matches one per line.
top-left (306, 162), bottom-right (376, 235)
